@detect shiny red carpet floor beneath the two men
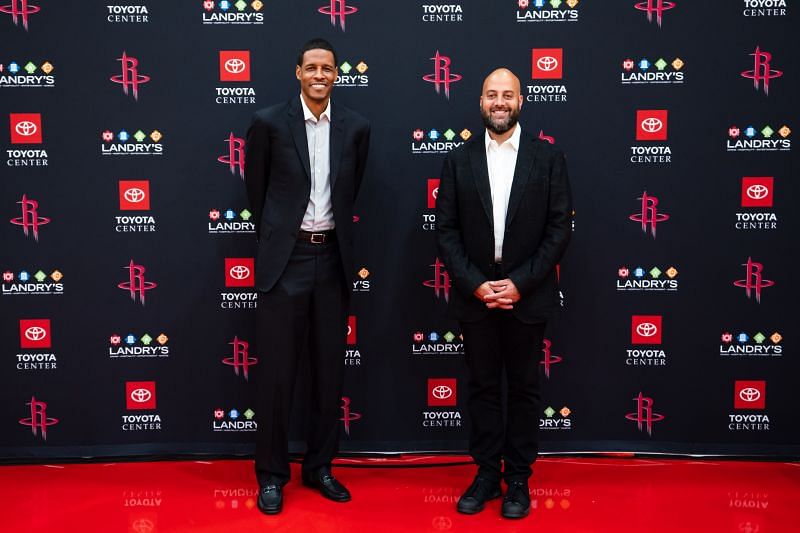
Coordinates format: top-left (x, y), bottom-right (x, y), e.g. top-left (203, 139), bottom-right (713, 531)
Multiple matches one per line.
top-left (0, 457), bottom-right (800, 533)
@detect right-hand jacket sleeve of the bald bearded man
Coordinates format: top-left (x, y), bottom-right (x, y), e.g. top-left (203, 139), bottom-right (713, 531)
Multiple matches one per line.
top-left (508, 151), bottom-right (572, 297)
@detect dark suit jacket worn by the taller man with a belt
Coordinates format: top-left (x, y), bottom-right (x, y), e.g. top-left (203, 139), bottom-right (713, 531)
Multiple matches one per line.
top-left (244, 95), bottom-right (370, 291)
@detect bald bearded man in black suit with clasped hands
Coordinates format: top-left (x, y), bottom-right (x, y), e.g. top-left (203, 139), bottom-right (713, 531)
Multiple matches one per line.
top-left (436, 69), bottom-right (572, 518)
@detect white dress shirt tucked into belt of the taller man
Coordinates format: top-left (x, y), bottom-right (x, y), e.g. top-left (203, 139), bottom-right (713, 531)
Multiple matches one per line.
top-left (300, 94), bottom-right (336, 231)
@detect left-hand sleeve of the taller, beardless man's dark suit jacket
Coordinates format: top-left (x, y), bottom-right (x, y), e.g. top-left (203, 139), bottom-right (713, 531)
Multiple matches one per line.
top-left (244, 114), bottom-right (269, 240)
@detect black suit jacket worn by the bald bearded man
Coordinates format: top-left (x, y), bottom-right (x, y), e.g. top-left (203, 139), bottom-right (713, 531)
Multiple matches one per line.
top-left (436, 133), bottom-right (572, 323)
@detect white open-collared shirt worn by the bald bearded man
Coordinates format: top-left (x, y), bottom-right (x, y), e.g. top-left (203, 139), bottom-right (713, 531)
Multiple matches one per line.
top-left (485, 124), bottom-right (522, 262)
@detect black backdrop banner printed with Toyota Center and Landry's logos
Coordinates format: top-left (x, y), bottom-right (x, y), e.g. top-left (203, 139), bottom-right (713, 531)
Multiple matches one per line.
top-left (0, 0), bottom-right (800, 458)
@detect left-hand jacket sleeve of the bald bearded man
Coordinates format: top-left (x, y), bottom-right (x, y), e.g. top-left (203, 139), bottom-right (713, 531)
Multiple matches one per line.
top-left (436, 155), bottom-right (487, 296)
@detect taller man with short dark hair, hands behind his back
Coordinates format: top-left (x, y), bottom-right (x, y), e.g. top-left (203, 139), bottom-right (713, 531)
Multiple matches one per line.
top-left (245, 39), bottom-right (370, 514)
